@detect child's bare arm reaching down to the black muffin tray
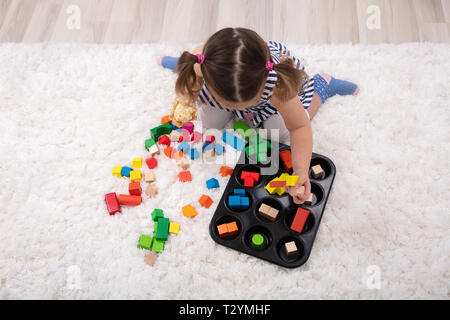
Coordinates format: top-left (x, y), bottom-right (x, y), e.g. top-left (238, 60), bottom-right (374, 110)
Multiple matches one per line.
top-left (271, 96), bottom-right (312, 203)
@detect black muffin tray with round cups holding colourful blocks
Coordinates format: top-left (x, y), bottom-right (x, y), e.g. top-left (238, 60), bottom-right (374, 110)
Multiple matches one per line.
top-left (209, 144), bottom-right (336, 268)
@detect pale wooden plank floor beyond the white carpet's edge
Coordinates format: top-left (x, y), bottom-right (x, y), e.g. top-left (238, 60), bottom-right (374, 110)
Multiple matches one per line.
top-left (0, 0), bottom-right (450, 43)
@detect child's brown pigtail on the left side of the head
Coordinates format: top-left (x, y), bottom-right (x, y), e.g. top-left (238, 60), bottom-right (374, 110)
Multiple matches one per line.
top-left (175, 51), bottom-right (198, 101)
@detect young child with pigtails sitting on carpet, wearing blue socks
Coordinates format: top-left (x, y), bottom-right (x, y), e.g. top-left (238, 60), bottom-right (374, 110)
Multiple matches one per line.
top-left (160, 28), bottom-right (359, 204)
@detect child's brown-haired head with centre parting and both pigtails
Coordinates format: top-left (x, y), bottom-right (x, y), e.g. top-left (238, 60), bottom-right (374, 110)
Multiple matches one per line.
top-left (175, 28), bottom-right (307, 108)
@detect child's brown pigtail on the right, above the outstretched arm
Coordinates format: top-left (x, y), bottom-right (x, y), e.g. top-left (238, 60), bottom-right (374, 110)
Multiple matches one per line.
top-left (273, 58), bottom-right (308, 101)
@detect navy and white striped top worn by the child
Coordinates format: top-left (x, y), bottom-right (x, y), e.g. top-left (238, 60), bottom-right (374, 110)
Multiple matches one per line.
top-left (198, 41), bottom-right (314, 128)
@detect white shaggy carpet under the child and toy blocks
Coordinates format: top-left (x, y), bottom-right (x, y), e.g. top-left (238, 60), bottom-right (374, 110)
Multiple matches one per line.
top-left (0, 44), bottom-right (450, 299)
